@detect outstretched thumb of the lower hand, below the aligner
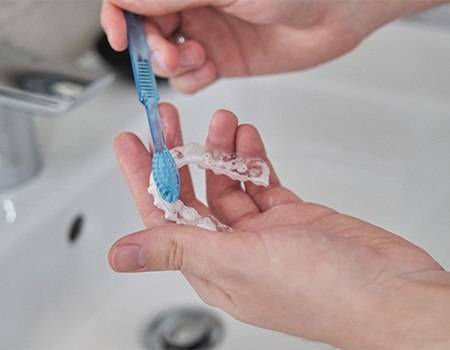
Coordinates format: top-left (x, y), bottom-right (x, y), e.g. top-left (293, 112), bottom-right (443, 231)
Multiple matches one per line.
top-left (109, 224), bottom-right (232, 277)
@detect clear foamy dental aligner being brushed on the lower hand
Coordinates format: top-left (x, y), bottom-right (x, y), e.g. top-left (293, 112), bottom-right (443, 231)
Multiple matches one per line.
top-left (148, 143), bottom-right (270, 232)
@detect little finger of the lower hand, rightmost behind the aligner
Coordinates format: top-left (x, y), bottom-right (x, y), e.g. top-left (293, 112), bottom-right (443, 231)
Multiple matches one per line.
top-left (236, 124), bottom-right (300, 212)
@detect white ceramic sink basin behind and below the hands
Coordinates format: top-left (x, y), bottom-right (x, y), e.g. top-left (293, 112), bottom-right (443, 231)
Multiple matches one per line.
top-left (0, 23), bottom-right (450, 349)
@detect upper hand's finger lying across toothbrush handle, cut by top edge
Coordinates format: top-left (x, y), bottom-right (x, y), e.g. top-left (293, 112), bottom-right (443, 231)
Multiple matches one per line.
top-left (107, 0), bottom-right (230, 16)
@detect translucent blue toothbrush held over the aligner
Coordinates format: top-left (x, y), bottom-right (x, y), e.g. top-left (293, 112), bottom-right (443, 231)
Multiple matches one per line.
top-left (125, 11), bottom-right (180, 203)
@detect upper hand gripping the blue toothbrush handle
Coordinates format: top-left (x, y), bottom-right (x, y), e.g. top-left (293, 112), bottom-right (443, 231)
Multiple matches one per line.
top-left (101, 0), bottom-right (445, 93)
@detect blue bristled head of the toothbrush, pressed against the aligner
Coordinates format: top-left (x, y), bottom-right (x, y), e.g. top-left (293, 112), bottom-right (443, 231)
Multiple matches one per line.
top-left (152, 148), bottom-right (180, 203)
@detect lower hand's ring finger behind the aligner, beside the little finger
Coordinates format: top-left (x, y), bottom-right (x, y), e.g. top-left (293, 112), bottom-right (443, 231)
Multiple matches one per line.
top-left (206, 110), bottom-right (259, 226)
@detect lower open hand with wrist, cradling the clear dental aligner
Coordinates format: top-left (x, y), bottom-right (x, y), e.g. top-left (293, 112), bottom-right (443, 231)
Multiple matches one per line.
top-left (109, 104), bottom-right (450, 349)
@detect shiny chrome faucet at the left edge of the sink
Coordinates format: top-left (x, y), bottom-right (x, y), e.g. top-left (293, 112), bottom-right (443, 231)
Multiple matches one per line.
top-left (0, 42), bottom-right (113, 192)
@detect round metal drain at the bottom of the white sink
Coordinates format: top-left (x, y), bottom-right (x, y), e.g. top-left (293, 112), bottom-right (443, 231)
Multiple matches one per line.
top-left (144, 307), bottom-right (223, 350)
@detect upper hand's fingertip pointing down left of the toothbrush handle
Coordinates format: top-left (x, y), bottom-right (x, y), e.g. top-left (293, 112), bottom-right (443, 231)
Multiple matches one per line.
top-left (100, 0), bottom-right (128, 51)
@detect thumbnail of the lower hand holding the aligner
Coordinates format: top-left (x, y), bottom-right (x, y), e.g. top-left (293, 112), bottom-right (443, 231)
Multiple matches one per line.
top-left (112, 244), bottom-right (147, 272)
